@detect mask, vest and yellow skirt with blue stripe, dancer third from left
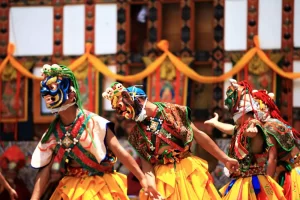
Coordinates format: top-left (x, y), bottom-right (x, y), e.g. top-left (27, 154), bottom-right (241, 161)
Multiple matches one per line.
top-left (220, 80), bottom-right (285, 200)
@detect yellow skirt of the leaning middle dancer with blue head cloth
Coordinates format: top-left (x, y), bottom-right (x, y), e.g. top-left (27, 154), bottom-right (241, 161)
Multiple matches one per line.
top-left (140, 156), bottom-right (221, 200)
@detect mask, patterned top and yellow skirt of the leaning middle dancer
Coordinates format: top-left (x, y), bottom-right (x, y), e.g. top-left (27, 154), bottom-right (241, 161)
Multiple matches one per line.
top-left (103, 83), bottom-right (220, 200)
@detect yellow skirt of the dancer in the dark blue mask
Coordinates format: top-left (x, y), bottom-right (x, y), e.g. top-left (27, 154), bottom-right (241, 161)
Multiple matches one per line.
top-left (50, 172), bottom-right (129, 200)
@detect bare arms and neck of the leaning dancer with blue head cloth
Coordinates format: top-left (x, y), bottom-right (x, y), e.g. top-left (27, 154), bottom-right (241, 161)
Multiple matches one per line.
top-left (115, 96), bottom-right (238, 199)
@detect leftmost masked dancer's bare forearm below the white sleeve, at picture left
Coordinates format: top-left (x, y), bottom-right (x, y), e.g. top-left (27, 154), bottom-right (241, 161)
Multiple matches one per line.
top-left (31, 162), bottom-right (53, 200)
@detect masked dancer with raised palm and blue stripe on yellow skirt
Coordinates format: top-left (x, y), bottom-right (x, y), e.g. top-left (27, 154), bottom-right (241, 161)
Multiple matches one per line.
top-left (204, 79), bottom-right (286, 200)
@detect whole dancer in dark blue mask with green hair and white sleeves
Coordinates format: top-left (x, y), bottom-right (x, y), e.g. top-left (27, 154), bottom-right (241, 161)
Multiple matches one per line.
top-left (31, 64), bottom-right (155, 200)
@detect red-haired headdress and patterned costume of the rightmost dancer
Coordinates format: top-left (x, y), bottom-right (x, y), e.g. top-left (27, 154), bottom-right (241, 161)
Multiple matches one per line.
top-left (252, 90), bottom-right (300, 200)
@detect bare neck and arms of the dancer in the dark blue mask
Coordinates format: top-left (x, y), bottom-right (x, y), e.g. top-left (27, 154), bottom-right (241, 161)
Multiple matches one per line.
top-left (31, 92), bottom-right (150, 200)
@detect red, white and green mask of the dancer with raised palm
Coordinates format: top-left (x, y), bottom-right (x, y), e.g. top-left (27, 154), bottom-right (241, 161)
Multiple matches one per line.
top-left (225, 79), bottom-right (258, 122)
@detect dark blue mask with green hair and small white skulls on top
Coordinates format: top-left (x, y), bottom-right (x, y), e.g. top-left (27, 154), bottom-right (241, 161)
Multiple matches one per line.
top-left (41, 64), bottom-right (79, 112)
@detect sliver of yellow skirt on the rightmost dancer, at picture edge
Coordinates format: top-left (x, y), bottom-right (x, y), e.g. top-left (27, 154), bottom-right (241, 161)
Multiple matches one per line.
top-left (283, 167), bottom-right (300, 200)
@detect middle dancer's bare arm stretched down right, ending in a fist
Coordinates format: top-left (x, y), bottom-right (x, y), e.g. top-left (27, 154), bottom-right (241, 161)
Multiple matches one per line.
top-left (191, 123), bottom-right (239, 171)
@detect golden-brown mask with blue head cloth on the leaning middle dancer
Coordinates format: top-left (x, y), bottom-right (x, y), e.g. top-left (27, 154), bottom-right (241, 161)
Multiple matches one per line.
top-left (102, 82), bottom-right (147, 121)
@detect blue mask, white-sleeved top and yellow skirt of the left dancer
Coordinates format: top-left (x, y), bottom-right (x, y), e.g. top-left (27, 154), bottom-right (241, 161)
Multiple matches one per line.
top-left (31, 65), bottom-right (128, 200)
